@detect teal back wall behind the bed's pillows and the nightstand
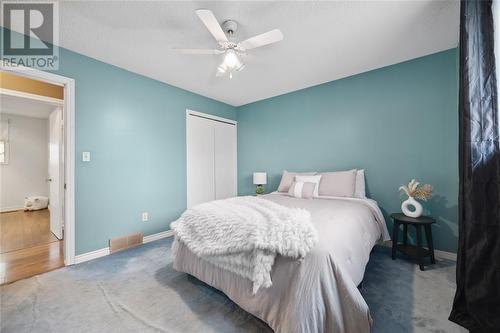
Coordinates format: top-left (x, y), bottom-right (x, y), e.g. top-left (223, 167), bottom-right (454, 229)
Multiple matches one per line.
top-left (237, 49), bottom-right (458, 252)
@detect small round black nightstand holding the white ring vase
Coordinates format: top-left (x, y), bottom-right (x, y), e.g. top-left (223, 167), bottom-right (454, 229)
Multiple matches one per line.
top-left (391, 213), bottom-right (436, 271)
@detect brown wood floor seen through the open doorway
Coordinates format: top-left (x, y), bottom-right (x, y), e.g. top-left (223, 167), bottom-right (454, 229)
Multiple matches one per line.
top-left (0, 209), bottom-right (64, 284)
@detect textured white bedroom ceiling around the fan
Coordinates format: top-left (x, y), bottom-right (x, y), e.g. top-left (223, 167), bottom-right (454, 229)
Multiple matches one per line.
top-left (56, 0), bottom-right (459, 106)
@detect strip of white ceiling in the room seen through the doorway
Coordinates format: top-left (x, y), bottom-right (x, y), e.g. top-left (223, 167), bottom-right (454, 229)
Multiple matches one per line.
top-left (0, 94), bottom-right (57, 118)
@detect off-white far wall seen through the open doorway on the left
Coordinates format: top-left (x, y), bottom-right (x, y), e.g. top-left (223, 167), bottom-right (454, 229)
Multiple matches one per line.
top-left (0, 114), bottom-right (49, 211)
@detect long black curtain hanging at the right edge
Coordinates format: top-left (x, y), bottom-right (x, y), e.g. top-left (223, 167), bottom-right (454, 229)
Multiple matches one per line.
top-left (450, 0), bottom-right (500, 333)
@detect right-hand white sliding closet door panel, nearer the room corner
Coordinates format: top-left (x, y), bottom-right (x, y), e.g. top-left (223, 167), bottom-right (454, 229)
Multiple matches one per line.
top-left (214, 121), bottom-right (237, 199)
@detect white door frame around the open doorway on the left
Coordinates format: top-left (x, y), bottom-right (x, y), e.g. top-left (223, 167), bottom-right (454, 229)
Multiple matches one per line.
top-left (0, 64), bottom-right (75, 266)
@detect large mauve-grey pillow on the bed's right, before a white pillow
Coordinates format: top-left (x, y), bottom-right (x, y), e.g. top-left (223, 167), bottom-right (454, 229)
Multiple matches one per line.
top-left (319, 169), bottom-right (356, 197)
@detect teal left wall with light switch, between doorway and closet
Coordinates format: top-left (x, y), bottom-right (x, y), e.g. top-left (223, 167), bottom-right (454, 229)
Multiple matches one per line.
top-left (0, 27), bottom-right (236, 255)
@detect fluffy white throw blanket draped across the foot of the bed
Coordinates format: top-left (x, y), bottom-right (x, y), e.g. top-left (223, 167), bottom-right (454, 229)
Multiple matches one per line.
top-left (171, 196), bottom-right (318, 294)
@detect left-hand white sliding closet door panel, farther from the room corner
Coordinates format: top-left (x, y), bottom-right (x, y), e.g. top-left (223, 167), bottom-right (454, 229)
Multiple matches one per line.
top-left (186, 115), bottom-right (215, 208)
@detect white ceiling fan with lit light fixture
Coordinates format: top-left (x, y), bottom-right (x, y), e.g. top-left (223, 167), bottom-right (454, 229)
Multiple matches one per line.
top-left (176, 9), bottom-right (283, 79)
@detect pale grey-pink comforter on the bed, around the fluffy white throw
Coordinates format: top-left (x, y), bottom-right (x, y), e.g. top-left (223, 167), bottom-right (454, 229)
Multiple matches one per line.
top-left (174, 192), bottom-right (389, 333)
